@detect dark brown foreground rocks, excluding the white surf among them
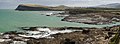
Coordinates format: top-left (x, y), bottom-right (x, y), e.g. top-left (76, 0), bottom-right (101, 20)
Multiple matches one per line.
top-left (0, 26), bottom-right (120, 44)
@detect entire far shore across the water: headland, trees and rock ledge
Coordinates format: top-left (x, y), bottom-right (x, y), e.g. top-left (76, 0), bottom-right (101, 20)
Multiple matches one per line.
top-left (16, 4), bottom-right (120, 25)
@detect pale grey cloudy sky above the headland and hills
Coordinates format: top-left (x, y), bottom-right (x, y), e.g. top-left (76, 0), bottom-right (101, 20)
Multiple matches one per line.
top-left (0, 0), bottom-right (120, 9)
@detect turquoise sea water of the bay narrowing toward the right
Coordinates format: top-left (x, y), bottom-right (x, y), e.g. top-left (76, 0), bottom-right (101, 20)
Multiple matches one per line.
top-left (0, 9), bottom-right (120, 32)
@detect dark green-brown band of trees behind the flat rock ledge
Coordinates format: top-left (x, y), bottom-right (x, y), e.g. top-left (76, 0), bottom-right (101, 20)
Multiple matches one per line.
top-left (65, 7), bottom-right (120, 14)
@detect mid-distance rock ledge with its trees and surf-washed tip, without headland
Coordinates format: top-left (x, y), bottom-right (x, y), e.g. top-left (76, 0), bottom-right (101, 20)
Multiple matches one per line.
top-left (39, 9), bottom-right (120, 25)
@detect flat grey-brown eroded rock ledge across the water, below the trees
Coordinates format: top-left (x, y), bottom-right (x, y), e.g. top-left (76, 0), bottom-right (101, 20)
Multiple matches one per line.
top-left (62, 12), bottom-right (120, 25)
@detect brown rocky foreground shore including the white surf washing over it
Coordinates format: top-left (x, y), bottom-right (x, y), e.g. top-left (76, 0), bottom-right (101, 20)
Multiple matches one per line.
top-left (0, 25), bottom-right (120, 44)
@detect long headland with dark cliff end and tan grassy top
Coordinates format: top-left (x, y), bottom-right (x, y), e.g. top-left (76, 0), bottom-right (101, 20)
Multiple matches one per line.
top-left (15, 4), bottom-right (69, 11)
